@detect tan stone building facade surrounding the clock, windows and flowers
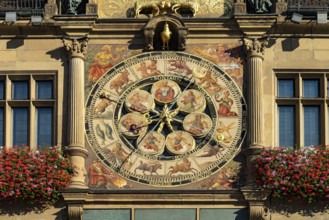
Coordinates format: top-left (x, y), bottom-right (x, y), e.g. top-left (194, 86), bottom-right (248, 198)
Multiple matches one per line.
top-left (0, 0), bottom-right (329, 220)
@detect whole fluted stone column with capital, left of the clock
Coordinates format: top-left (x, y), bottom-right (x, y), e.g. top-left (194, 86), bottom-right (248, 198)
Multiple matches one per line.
top-left (63, 38), bottom-right (88, 188)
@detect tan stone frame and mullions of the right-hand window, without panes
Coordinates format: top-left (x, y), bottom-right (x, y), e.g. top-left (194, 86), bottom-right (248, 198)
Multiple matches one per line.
top-left (274, 70), bottom-right (329, 148)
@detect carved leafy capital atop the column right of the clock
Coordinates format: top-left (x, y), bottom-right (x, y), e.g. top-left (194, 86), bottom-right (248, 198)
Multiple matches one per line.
top-left (243, 37), bottom-right (269, 59)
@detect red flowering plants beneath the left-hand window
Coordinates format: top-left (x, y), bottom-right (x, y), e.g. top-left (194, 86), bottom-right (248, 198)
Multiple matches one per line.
top-left (0, 146), bottom-right (73, 207)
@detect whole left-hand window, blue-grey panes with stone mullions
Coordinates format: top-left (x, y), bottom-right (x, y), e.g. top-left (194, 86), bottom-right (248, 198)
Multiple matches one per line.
top-left (0, 74), bottom-right (55, 147)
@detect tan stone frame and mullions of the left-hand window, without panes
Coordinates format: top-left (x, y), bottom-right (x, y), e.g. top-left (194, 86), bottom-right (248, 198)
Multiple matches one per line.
top-left (0, 71), bottom-right (58, 148)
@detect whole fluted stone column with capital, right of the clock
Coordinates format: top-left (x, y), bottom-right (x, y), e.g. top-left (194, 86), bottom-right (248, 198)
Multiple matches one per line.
top-left (243, 38), bottom-right (268, 185)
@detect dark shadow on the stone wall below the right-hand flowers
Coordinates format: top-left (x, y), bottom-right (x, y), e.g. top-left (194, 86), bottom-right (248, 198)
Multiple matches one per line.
top-left (270, 197), bottom-right (329, 217)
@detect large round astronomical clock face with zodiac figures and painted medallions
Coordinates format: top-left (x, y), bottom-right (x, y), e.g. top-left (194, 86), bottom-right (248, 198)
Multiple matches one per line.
top-left (85, 52), bottom-right (246, 187)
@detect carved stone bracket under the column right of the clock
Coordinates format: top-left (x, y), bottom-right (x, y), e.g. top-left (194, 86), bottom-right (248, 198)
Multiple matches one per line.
top-left (241, 187), bottom-right (271, 220)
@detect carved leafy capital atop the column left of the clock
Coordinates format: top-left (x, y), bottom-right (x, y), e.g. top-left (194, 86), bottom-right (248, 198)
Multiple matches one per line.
top-left (63, 37), bottom-right (88, 59)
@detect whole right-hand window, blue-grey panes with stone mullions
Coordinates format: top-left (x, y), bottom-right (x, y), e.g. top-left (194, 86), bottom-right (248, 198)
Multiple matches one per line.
top-left (276, 73), bottom-right (329, 147)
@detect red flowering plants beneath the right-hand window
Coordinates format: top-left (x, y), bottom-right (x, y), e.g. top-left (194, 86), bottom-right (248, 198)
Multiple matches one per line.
top-left (256, 147), bottom-right (329, 202)
